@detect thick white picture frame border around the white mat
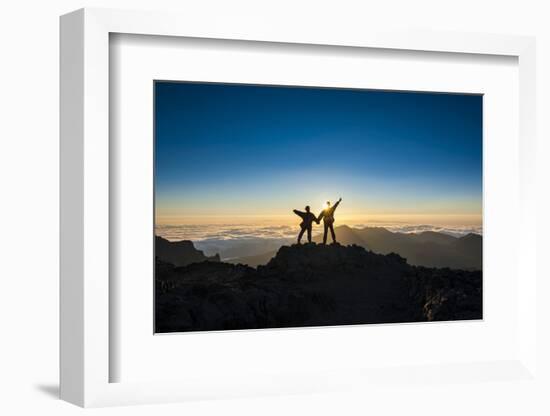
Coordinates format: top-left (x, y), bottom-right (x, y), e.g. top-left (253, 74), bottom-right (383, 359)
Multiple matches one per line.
top-left (60, 9), bottom-right (537, 407)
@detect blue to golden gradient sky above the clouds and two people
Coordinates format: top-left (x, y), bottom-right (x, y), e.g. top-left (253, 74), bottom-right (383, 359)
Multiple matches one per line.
top-left (155, 82), bottom-right (482, 228)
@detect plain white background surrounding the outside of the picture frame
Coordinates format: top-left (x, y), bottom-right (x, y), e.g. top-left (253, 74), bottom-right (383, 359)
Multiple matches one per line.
top-left (0, 0), bottom-right (550, 415)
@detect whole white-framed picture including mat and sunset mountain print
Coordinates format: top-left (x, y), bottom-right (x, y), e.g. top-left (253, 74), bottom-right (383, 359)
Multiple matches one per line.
top-left (61, 9), bottom-right (537, 406)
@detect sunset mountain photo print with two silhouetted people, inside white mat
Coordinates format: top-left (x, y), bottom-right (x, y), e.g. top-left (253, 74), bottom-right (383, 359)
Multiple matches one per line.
top-left (154, 81), bottom-right (483, 333)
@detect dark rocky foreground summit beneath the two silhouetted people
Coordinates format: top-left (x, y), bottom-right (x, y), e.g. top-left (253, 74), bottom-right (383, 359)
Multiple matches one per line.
top-left (155, 243), bottom-right (482, 332)
